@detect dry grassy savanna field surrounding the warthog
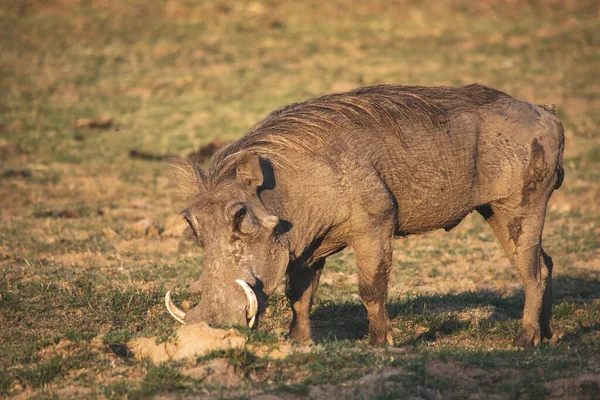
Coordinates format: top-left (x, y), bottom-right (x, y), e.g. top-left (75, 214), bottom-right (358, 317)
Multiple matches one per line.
top-left (0, 0), bottom-right (600, 399)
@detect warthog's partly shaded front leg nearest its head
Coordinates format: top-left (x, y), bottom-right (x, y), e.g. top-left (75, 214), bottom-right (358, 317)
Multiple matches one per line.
top-left (286, 259), bottom-right (325, 342)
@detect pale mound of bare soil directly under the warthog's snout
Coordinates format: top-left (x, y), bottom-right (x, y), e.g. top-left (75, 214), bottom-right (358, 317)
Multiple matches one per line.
top-left (128, 322), bottom-right (246, 363)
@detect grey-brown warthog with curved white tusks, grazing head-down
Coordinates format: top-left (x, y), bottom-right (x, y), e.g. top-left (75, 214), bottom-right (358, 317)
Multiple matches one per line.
top-left (166, 85), bottom-right (564, 346)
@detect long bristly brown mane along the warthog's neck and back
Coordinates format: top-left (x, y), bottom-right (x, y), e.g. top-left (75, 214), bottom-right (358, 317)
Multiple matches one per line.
top-left (208, 84), bottom-right (507, 182)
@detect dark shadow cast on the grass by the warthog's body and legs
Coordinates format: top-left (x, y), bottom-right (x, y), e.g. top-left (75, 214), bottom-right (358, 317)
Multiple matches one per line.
top-left (310, 275), bottom-right (600, 345)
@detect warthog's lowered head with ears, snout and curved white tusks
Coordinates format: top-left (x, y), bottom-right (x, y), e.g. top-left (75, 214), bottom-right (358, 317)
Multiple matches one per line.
top-left (165, 154), bottom-right (289, 328)
